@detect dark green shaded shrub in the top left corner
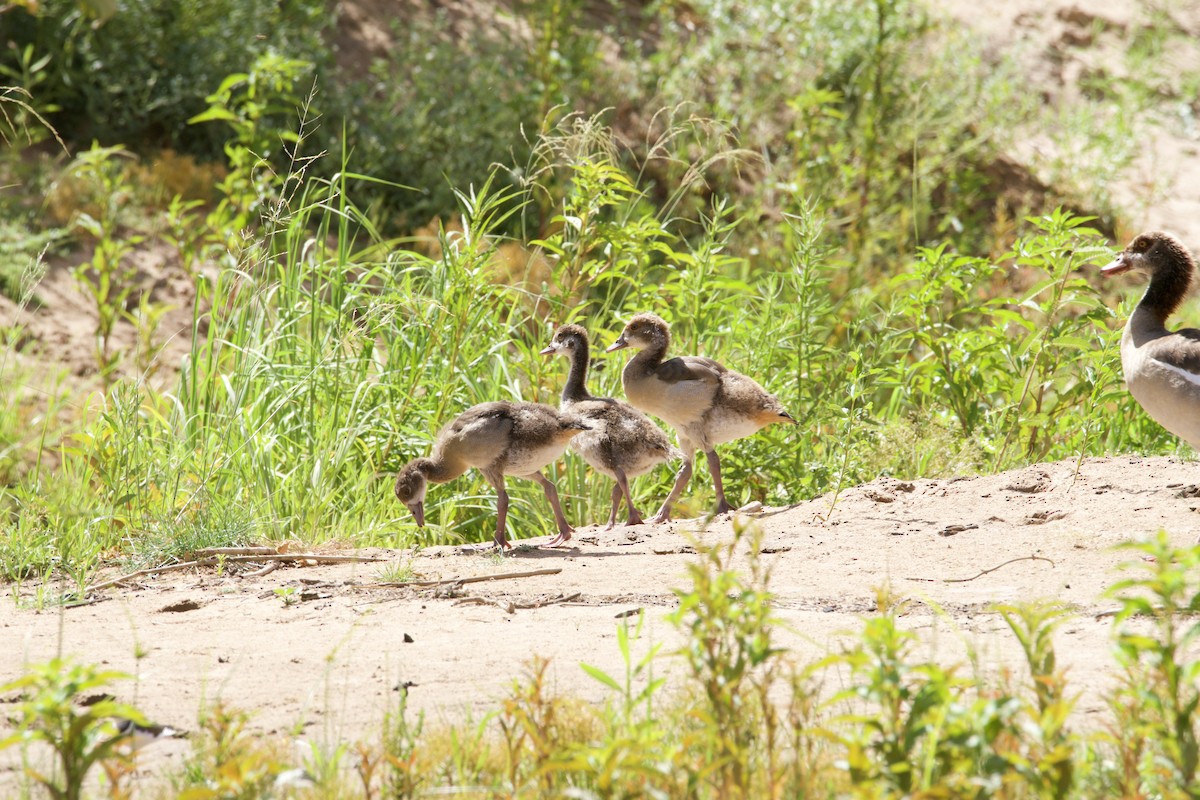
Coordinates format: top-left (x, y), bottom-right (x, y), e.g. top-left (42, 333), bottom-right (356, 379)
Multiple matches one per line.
top-left (0, 0), bottom-right (330, 155)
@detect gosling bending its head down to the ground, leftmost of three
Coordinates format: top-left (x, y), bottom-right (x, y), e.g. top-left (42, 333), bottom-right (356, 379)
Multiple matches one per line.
top-left (396, 402), bottom-right (589, 549)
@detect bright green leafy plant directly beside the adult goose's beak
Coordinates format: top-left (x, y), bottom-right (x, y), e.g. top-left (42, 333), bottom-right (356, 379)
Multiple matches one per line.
top-left (888, 210), bottom-right (1117, 468)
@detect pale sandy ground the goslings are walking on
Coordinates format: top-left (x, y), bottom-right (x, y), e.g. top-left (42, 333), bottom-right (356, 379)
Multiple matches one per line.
top-left (0, 457), bottom-right (1200, 786)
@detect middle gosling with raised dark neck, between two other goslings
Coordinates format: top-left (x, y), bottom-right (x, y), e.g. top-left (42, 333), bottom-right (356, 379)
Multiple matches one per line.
top-left (541, 325), bottom-right (682, 530)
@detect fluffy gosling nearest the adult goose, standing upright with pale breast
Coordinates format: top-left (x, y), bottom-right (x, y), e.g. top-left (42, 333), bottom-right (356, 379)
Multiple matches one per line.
top-left (608, 314), bottom-right (796, 522)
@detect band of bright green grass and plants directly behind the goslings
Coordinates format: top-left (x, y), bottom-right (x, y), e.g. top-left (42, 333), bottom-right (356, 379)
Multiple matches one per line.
top-left (0, 106), bottom-right (1174, 587)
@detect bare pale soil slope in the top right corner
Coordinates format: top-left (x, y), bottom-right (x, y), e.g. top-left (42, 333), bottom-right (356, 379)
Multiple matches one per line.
top-left (930, 0), bottom-right (1200, 244)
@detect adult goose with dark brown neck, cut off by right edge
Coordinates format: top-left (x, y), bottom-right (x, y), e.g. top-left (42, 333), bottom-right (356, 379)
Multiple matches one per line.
top-left (1100, 230), bottom-right (1200, 450)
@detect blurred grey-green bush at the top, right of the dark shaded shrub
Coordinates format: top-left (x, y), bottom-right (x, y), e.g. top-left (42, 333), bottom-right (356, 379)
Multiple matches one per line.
top-left (325, 0), bottom-right (607, 227)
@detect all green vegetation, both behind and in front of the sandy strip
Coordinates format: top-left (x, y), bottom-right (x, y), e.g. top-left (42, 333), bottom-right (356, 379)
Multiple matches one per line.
top-left (0, 0), bottom-right (1200, 798)
